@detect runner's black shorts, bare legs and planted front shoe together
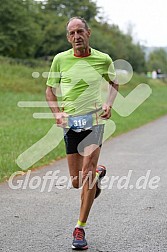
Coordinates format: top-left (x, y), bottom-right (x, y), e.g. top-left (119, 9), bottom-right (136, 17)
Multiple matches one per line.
top-left (65, 127), bottom-right (103, 249)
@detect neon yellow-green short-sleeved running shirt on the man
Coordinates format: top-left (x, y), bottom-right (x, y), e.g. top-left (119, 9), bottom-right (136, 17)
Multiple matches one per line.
top-left (46, 48), bottom-right (116, 115)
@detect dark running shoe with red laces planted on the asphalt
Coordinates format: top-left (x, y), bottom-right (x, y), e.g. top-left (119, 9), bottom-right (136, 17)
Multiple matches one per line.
top-left (72, 227), bottom-right (88, 250)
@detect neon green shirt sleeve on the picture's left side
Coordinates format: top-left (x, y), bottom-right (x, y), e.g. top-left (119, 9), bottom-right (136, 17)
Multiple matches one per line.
top-left (46, 55), bottom-right (61, 87)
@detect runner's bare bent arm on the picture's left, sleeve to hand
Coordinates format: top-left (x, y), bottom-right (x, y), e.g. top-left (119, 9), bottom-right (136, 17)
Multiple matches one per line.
top-left (46, 86), bottom-right (68, 127)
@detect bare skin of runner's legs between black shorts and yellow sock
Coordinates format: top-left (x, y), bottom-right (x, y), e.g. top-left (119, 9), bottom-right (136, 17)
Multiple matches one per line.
top-left (67, 145), bottom-right (100, 223)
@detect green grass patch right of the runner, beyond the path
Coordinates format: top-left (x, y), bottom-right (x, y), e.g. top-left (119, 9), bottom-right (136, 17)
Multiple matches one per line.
top-left (112, 76), bottom-right (167, 136)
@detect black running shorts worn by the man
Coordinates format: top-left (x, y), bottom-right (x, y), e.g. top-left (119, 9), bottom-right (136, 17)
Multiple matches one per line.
top-left (64, 124), bottom-right (104, 154)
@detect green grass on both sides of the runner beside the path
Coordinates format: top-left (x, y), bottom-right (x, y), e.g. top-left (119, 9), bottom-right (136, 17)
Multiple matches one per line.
top-left (0, 58), bottom-right (167, 181)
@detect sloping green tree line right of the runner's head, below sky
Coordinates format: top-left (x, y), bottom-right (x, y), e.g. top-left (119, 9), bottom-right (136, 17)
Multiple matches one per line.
top-left (91, 21), bottom-right (145, 72)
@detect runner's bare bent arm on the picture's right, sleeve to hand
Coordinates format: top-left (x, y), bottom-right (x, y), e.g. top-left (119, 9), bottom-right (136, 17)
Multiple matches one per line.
top-left (101, 80), bottom-right (119, 119)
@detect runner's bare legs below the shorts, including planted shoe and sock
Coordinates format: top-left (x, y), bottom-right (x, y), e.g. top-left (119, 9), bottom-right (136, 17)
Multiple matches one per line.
top-left (67, 145), bottom-right (100, 249)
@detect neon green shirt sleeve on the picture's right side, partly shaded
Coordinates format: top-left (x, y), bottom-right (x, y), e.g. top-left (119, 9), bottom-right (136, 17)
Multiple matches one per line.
top-left (103, 54), bottom-right (116, 82)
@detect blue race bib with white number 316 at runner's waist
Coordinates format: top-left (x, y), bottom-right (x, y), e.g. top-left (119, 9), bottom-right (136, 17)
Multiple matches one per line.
top-left (68, 115), bottom-right (93, 129)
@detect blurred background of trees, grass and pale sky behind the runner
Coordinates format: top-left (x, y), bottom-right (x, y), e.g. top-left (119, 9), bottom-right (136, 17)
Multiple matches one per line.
top-left (0, 0), bottom-right (167, 181)
